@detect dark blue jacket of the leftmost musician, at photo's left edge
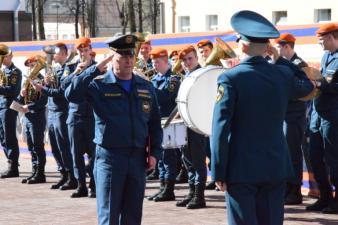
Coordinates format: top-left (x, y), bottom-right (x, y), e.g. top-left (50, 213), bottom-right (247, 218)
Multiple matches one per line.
top-left (0, 63), bottom-right (22, 109)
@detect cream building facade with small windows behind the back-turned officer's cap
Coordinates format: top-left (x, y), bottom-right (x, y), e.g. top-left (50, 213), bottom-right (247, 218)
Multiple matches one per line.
top-left (161, 0), bottom-right (338, 33)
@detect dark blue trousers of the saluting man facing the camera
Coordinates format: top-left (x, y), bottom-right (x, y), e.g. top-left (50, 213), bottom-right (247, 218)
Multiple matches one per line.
top-left (94, 146), bottom-right (146, 225)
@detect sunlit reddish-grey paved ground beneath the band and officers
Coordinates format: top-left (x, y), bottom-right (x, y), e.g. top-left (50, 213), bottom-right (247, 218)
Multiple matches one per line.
top-left (0, 152), bottom-right (338, 225)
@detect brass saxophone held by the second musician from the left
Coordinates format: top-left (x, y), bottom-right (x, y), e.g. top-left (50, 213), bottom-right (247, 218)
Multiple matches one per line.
top-left (23, 55), bottom-right (46, 104)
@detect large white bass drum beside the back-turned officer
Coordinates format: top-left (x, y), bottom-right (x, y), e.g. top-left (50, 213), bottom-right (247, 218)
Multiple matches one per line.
top-left (176, 66), bottom-right (226, 136)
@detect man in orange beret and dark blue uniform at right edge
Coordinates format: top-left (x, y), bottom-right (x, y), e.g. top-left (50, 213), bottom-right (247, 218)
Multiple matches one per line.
top-left (306, 23), bottom-right (338, 214)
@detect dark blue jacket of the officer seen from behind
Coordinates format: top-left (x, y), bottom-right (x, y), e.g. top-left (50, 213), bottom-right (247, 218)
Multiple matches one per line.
top-left (210, 56), bottom-right (313, 183)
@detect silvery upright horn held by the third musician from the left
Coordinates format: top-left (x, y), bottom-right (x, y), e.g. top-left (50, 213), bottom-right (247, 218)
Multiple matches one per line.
top-left (42, 45), bottom-right (58, 88)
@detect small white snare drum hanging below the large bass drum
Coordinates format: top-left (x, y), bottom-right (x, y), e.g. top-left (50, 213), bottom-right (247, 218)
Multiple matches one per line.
top-left (162, 120), bottom-right (187, 149)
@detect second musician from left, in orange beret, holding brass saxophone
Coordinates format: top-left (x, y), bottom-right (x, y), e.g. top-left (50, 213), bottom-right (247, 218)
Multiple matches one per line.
top-left (17, 56), bottom-right (47, 184)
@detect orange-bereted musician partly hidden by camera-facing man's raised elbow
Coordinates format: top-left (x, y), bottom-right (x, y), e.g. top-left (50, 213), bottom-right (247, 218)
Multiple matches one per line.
top-left (61, 37), bottom-right (96, 198)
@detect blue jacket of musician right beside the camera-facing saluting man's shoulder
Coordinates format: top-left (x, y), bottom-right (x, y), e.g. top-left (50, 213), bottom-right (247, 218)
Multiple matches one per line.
top-left (151, 68), bottom-right (180, 117)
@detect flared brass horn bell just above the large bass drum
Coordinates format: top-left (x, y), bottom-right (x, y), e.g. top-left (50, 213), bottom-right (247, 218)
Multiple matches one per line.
top-left (205, 38), bottom-right (236, 66)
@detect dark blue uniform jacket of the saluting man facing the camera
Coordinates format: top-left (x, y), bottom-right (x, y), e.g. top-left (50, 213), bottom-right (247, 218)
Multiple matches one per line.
top-left (65, 65), bottom-right (162, 158)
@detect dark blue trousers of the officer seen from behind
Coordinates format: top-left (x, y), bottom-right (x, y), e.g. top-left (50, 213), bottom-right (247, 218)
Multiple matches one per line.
top-left (225, 181), bottom-right (285, 225)
